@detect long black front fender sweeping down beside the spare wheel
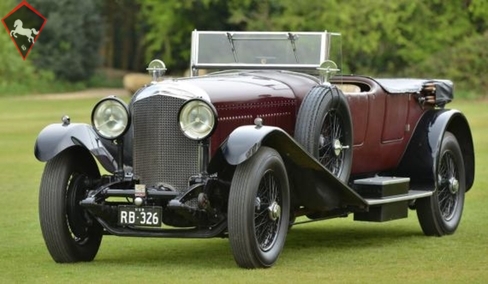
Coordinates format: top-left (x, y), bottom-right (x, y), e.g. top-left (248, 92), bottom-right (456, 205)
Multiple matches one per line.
top-left (220, 125), bottom-right (367, 210)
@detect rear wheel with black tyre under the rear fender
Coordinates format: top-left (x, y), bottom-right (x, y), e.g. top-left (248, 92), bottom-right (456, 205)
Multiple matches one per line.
top-left (416, 132), bottom-right (466, 236)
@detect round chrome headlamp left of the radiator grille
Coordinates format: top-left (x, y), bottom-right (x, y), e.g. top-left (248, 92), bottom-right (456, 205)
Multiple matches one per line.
top-left (92, 96), bottom-right (130, 140)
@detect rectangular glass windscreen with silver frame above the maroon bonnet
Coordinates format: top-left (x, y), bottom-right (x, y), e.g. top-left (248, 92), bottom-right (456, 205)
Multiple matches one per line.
top-left (193, 32), bottom-right (327, 66)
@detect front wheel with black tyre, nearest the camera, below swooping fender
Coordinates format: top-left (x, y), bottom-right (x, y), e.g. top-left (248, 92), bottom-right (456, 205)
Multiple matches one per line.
top-left (228, 147), bottom-right (290, 268)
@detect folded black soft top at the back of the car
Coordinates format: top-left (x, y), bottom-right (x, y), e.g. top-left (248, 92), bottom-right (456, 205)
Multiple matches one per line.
top-left (373, 79), bottom-right (454, 106)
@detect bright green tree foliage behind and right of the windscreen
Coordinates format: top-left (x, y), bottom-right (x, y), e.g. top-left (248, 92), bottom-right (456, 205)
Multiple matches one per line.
top-left (225, 0), bottom-right (488, 93)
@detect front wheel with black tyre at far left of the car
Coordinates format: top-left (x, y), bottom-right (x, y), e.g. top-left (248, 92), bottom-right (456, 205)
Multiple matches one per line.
top-left (39, 148), bottom-right (103, 263)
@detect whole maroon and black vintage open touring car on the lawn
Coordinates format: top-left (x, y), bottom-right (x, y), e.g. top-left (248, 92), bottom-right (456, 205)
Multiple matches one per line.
top-left (35, 31), bottom-right (475, 268)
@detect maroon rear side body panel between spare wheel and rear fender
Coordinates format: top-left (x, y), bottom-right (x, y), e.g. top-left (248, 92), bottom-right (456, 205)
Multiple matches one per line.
top-left (333, 76), bottom-right (426, 175)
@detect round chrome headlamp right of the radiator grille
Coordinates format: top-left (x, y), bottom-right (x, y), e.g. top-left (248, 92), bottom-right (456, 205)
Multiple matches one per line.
top-left (178, 99), bottom-right (217, 140)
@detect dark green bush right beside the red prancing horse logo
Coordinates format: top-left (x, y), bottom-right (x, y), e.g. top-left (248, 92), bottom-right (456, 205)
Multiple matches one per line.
top-left (29, 0), bottom-right (103, 81)
